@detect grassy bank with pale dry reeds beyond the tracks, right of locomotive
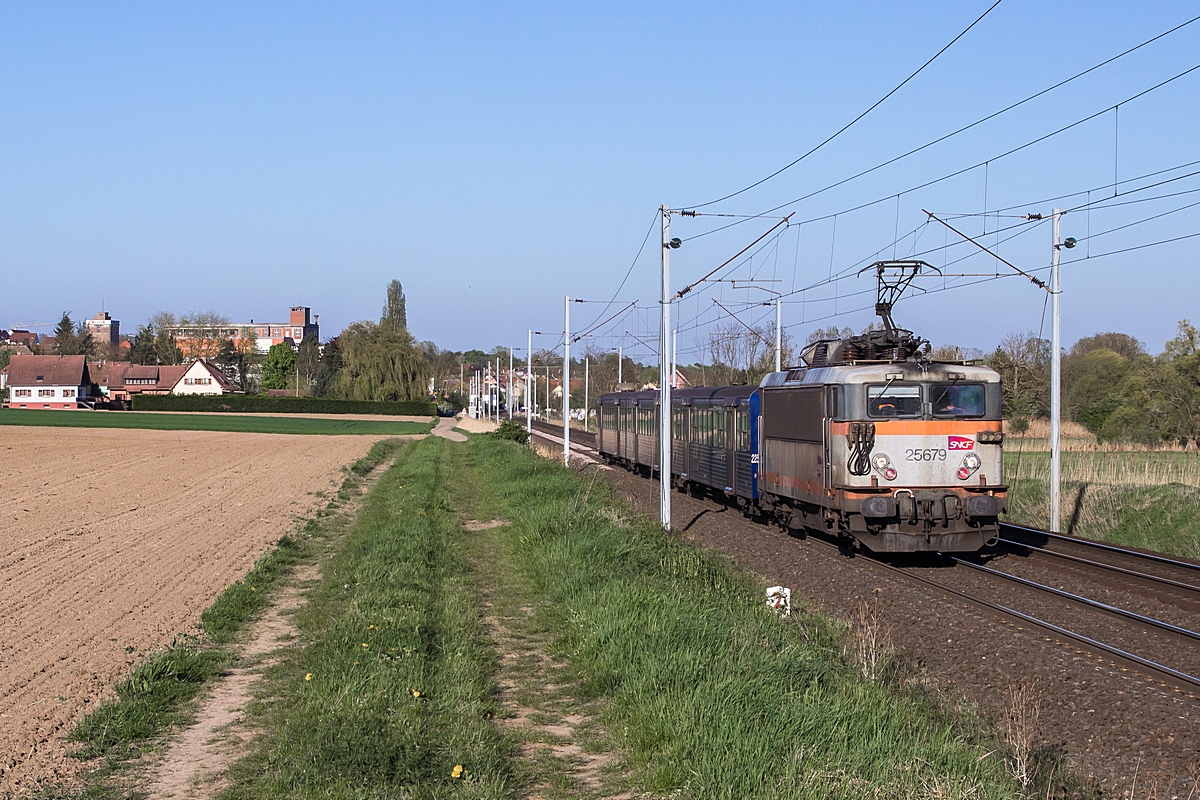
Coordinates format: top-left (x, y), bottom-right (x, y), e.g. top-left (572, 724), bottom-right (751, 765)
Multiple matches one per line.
top-left (1004, 451), bottom-right (1200, 559)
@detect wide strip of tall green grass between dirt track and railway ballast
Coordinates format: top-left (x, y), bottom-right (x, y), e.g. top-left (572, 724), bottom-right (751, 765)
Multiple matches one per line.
top-left (460, 437), bottom-right (1020, 799)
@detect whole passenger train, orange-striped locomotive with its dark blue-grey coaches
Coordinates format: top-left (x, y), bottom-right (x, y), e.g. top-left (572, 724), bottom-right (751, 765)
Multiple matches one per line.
top-left (595, 317), bottom-right (1008, 554)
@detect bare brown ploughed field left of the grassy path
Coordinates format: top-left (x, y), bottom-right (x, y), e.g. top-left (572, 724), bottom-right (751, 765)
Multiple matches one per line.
top-left (0, 427), bottom-right (377, 794)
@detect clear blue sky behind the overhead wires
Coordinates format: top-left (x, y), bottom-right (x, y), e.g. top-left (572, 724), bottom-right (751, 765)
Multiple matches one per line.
top-left (0, 0), bottom-right (1200, 361)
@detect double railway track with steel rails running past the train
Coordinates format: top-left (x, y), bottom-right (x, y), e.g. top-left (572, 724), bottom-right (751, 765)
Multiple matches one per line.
top-left (533, 421), bottom-right (1200, 699)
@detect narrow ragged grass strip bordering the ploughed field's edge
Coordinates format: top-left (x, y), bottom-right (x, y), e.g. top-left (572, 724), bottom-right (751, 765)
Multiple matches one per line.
top-left (59, 440), bottom-right (403, 798)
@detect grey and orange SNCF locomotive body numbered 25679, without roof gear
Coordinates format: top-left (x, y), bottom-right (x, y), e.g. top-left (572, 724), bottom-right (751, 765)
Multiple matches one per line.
top-left (758, 353), bottom-right (1008, 553)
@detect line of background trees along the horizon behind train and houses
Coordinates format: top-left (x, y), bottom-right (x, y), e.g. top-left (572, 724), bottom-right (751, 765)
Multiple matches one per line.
top-left (16, 291), bottom-right (1200, 447)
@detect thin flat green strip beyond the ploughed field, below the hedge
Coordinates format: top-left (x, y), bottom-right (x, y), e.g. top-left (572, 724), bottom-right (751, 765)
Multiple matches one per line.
top-left (0, 408), bottom-right (433, 437)
